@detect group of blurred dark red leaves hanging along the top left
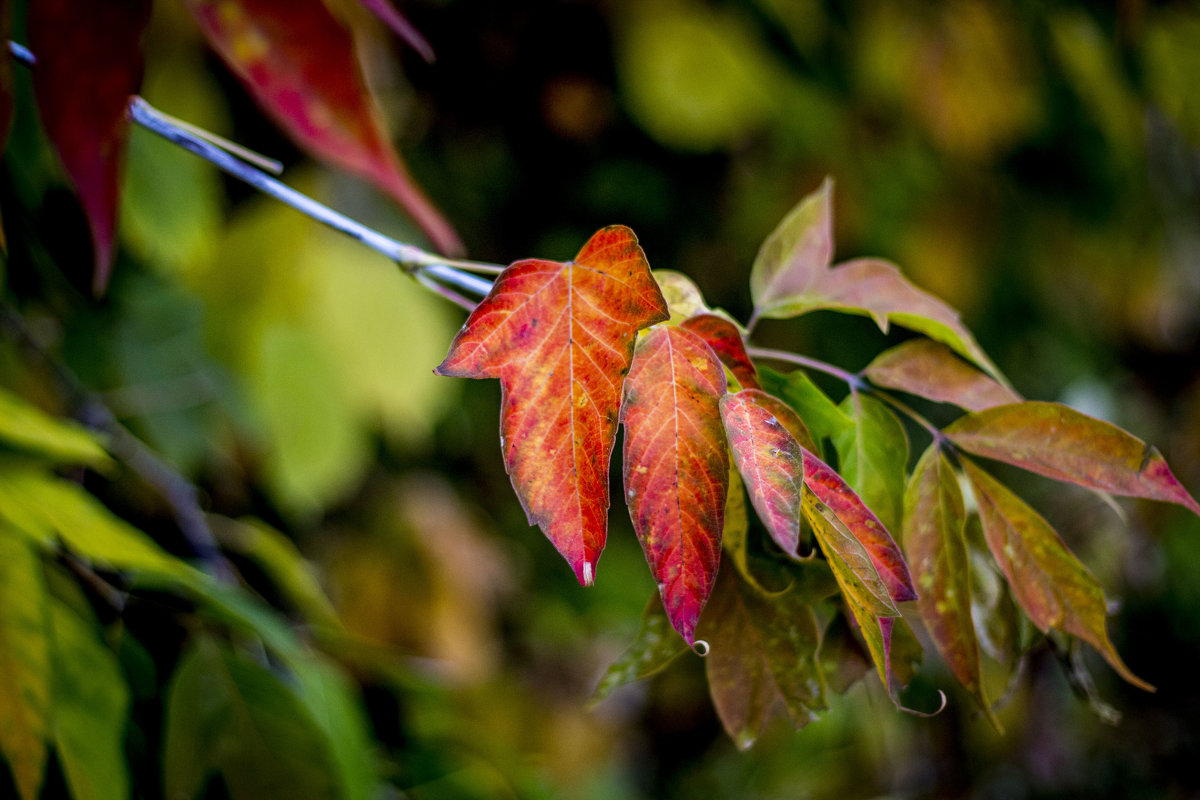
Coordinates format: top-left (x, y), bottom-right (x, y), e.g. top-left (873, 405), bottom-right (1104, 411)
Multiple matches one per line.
top-left (0, 0), bottom-right (453, 294)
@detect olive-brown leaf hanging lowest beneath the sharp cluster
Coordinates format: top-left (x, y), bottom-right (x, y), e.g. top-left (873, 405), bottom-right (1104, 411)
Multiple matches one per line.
top-left (698, 570), bottom-right (826, 750)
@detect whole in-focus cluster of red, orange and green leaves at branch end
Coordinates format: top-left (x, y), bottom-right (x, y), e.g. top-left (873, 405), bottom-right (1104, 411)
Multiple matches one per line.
top-left (438, 181), bottom-right (1200, 745)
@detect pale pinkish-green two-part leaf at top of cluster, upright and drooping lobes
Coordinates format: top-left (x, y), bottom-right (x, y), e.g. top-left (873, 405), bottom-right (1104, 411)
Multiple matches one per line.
top-left (750, 179), bottom-right (1003, 380)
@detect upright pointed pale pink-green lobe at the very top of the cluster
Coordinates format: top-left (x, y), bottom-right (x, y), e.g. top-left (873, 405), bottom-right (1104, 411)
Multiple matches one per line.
top-left (750, 178), bottom-right (833, 319)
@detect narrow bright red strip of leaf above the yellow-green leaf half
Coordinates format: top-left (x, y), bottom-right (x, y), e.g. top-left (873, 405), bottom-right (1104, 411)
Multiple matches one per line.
top-left (804, 451), bottom-right (917, 603)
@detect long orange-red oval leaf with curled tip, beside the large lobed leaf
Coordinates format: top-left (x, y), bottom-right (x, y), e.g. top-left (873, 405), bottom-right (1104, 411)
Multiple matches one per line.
top-left (620, 326), bottom-right (730, 644)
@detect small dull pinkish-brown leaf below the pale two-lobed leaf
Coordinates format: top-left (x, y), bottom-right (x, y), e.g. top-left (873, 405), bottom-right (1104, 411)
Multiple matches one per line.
top-left (863, 338), bottom-right (1021, 411)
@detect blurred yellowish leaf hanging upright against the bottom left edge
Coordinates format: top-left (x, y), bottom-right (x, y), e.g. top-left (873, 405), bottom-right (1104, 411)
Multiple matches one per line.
top-left (0, 523), bottom-right (53, 800)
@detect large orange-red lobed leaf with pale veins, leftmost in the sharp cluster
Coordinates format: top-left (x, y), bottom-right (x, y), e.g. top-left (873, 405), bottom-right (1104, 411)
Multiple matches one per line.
top-left (434, 225), bottom-right (667, 585)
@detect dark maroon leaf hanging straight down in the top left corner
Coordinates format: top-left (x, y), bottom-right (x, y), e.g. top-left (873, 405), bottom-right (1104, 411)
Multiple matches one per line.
top-left (28, 0), bottom-right (150, 294)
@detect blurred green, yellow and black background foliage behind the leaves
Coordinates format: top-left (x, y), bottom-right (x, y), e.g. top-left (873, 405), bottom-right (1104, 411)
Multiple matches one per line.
top-left (7, 0), bottom-right (1200, 800)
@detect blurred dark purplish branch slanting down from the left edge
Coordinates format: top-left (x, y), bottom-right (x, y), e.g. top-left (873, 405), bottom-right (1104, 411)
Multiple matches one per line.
top-left (0, 302), bottom-right (233, 581)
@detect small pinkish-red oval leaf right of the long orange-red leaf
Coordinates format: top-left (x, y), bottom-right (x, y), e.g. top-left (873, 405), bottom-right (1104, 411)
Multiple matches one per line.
top-left (721, 389), bottom-right (811, 555)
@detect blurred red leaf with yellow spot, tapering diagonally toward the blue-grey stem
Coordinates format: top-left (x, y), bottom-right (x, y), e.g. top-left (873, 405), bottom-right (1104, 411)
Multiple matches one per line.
top-left (186, 0), bottom-right (462, 254)
